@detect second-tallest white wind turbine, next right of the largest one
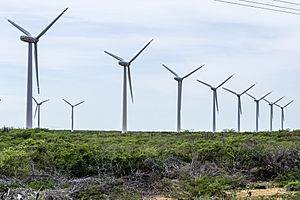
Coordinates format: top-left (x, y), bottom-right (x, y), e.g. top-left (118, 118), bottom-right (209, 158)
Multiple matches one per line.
top-left (104, 39), bottom-right (153, 133)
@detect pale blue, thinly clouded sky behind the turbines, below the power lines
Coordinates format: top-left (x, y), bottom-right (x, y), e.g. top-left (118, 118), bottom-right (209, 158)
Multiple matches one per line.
top-left (0, 0), bottom-right (300, 131)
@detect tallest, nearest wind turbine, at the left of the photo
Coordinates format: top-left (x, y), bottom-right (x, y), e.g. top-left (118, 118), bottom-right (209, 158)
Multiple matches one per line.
top-left (7, 8), bottom-right (68, 128)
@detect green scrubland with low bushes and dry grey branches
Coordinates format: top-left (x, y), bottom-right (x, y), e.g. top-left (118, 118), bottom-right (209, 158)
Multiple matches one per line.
top-left (0, 129), bottom-right (300, 200)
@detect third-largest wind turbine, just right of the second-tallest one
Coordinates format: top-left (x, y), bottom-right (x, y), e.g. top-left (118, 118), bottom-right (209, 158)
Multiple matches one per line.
top-left (162, 64), bottom-right (204, 132)
